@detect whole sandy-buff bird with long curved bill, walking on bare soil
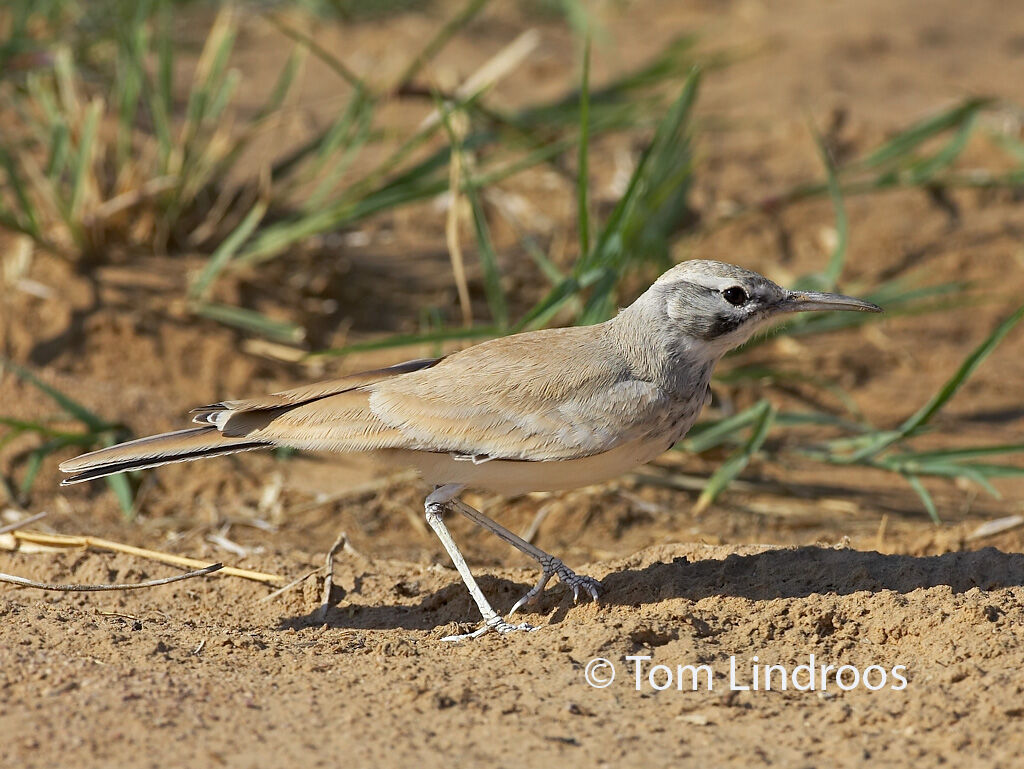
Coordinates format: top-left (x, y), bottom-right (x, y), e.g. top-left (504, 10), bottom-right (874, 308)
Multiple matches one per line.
top-left (60, 259), bottom-right (882, 641)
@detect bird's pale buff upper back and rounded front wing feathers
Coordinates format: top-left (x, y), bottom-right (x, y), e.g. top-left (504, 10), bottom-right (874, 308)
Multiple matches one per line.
top-left (367, 326), bottom-right (667, 460)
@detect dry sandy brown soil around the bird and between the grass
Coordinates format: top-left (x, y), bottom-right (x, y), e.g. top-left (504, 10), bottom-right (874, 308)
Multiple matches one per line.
top-left (0, 0), bottom-right (1024, 769)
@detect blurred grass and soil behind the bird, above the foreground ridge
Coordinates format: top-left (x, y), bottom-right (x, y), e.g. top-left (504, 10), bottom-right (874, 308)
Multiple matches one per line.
top-left (0, 0), bottom-right (1024, 563)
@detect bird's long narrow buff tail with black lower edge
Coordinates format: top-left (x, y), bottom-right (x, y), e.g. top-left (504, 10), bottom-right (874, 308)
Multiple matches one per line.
top-left (60, 427), bottom-right (273, 486)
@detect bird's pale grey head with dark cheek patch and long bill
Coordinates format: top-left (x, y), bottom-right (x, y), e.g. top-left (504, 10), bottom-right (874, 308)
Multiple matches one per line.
top-left (643, 259), bottom-right (882, 355)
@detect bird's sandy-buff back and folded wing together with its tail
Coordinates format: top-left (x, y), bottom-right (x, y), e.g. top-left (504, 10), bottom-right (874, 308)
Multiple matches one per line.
top-left (60, 327), bottom-right (665, 483)
